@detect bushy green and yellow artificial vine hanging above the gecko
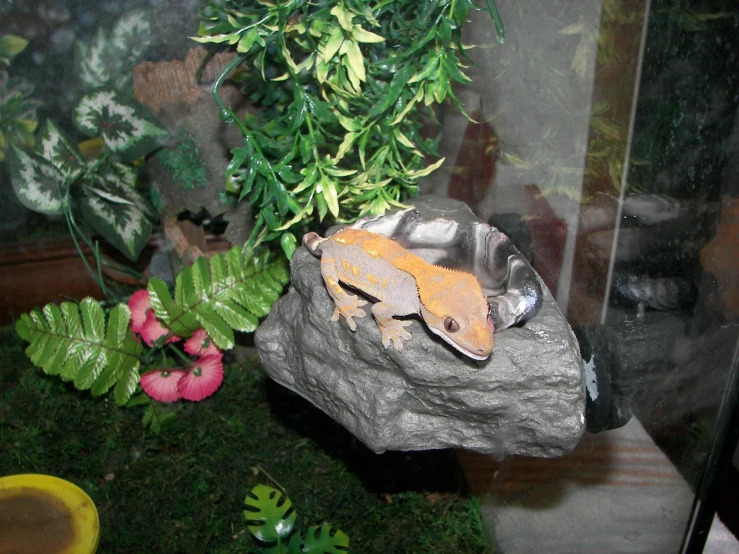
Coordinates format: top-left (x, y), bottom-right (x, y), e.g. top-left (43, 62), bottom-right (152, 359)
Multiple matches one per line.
top-left (195, 0), bottom-right (502, 255)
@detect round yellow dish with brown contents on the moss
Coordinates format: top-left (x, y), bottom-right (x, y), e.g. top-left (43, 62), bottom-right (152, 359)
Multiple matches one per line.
top-left (0, 474), bottom-right (100, 554)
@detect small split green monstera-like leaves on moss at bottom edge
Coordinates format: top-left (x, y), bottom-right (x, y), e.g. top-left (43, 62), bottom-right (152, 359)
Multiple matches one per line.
top-left (244, 485), bottom-right (349, 554)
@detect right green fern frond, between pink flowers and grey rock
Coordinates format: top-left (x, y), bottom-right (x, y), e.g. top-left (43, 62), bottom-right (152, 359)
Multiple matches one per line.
top-left (149, 246), bottom-right (290, 350)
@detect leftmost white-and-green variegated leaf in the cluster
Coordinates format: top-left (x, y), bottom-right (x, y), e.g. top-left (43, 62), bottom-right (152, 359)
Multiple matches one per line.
top-left (9, 146), bottom-right (64, 214)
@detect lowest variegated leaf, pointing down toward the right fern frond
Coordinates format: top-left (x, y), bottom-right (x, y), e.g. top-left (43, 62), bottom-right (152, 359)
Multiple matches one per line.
top-left (80, 179), bottom-right (151, 260)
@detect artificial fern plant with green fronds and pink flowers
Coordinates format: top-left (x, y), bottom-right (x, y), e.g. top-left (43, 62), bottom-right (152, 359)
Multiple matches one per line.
top-left (15, 246), bottom-right (289, 432)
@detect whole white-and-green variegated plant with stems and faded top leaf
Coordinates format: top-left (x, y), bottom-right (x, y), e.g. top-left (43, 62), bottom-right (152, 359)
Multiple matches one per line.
top-left (9, 10), bottom-right (167, 284)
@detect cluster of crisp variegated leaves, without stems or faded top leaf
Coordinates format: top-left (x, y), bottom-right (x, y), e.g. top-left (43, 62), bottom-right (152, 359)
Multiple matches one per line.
top-left (10, 88), bottom-right (167, 260)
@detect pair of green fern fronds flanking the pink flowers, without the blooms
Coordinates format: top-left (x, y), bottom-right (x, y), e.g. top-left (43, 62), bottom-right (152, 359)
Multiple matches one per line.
top-left (16, 247), bottom-right (289, 408)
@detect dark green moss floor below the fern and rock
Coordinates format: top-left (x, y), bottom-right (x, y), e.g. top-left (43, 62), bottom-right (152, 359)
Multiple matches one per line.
top-left (0, 328), bottom-right (486, 554)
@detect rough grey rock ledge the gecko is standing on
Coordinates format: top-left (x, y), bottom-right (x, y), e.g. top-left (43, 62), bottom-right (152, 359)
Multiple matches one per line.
top-left (255, 198), bottom-right (585, 457)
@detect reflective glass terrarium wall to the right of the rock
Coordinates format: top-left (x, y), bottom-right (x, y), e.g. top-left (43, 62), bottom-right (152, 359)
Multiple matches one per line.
top-left (427, 0), bottom-right (739, 552)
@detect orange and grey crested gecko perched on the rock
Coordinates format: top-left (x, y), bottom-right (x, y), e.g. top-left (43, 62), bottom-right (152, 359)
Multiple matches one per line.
top-left (303, 228), bottom-right (493, 360)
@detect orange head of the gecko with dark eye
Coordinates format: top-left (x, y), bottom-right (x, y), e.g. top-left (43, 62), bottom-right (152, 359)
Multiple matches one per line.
top-left (421, 275), bottom-right (493, 360)
